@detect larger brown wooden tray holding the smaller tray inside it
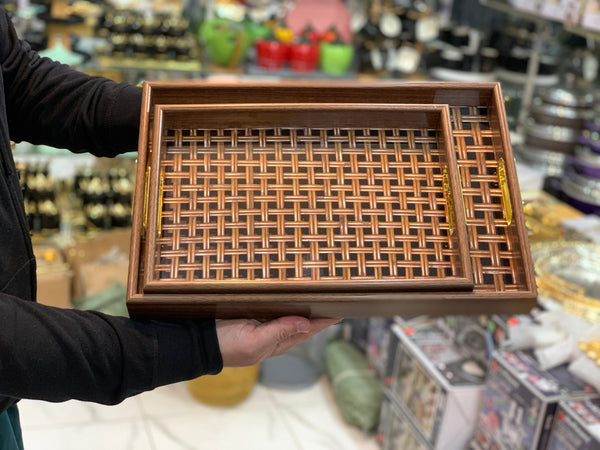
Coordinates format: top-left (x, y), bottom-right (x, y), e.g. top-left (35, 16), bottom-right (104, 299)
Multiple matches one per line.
top-left (128, 82), bottom-right (536, 317)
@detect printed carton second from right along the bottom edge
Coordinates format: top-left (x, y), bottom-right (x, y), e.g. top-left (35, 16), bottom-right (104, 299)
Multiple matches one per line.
top-left (471, 350), bottom-right (596, 450)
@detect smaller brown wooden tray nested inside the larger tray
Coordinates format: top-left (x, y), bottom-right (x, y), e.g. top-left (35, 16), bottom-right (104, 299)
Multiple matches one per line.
top-left (134, 104), bottom-right (473, 298)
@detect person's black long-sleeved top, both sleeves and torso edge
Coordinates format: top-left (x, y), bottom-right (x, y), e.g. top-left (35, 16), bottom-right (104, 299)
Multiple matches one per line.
top-left (0, 9), bottom-right (222, 412)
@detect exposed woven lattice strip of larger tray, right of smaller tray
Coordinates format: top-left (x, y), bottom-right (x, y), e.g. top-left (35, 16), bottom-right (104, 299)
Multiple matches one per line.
top-left (451, 107), bottom-right (523, 291)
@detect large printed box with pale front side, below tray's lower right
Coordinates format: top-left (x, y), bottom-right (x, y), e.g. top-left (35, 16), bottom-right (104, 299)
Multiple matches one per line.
top-left (386, 320), bottom-right (485, 449)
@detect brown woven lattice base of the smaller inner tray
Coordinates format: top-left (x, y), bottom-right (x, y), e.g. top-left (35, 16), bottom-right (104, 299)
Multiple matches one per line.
top-left (154, 128), bottom-right (465, 282)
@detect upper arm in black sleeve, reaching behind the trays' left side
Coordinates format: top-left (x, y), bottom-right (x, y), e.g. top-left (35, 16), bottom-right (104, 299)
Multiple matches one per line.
top-left (0, 9), bottom-right (142, 156)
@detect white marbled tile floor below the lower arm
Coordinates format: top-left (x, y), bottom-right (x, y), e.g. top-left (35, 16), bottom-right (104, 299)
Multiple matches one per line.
top-left (19, 377), bottom-right (378, 450)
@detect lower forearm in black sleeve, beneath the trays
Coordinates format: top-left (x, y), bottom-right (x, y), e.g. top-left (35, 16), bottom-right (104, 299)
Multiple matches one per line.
top-left (0, 294), bottom-right (222, 404)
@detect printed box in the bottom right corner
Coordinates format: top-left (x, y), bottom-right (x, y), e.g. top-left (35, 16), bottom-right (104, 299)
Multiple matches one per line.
top-left (546, 398), bottom-right (600, 450)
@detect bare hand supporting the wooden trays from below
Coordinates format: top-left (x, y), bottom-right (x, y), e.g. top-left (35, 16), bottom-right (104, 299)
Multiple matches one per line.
top-left (217, 316), bottom-right (339, 367)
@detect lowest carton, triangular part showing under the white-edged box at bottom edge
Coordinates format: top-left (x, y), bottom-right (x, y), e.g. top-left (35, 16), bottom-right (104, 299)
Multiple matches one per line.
top-left (377, 394), bottom-right (431, 450)
